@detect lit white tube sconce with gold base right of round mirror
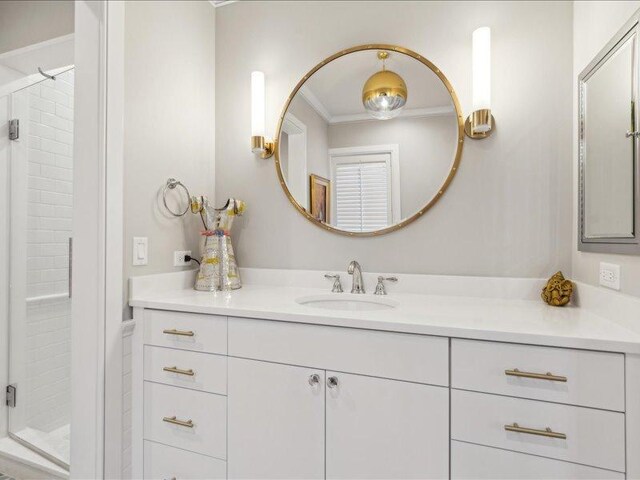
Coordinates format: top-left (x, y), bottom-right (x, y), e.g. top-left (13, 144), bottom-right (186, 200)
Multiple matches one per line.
top-left (464, 27), bottom-right (495, 139)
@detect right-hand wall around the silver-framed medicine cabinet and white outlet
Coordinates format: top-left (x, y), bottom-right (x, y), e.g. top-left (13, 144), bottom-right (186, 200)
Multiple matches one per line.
top-left (572, 1), bottom-right (640, 296)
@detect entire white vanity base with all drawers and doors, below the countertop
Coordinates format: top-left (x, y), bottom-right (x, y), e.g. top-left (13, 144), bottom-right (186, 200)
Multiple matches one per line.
top-left (133, 308), bottom-right (640, 480)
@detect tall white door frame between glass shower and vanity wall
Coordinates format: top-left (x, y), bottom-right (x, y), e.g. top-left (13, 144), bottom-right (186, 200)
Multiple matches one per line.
top-left (71, 0), bottom-right (124, 479)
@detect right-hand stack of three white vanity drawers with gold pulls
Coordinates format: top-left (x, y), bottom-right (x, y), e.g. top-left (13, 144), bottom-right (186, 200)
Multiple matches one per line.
top-left (451, 339), bottom-right (626, 479)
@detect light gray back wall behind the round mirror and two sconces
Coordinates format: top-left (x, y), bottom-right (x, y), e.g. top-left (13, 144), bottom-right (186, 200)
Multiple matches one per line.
top-left (216, 1), bottom-right (573, 277)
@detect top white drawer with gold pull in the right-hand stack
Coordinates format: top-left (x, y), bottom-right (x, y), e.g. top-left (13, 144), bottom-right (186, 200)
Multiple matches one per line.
top-left (451, 339), bottom-right (624, 411)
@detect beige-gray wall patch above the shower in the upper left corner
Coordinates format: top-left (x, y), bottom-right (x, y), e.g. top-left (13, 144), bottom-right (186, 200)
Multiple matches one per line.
top-left (0, 0), bottom-right (74, 53)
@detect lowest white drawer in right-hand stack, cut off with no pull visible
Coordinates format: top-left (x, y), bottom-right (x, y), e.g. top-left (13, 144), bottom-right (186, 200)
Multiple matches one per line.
top-left (451, 441), bottom-right (624, 480)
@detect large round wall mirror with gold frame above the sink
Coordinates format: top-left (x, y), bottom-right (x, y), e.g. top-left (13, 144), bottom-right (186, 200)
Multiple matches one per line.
top-left (275, 44), bottom-right (464, 236)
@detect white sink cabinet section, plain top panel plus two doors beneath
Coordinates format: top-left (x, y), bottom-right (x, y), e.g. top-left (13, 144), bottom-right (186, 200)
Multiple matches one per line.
top-left (229, 318), bottom-right (449, 479)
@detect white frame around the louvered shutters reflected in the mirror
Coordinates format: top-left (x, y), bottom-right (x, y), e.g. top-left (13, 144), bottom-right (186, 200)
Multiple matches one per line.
top-left (329, 143), bottom-right (402, 224)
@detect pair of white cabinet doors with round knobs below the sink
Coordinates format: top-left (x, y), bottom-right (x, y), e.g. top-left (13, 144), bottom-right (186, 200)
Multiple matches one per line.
top-left (229, 358), bottom-right (449, 479)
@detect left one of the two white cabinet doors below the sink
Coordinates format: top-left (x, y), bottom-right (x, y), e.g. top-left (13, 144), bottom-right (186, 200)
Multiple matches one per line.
top-left (227, 358), bottom-right (325, 479)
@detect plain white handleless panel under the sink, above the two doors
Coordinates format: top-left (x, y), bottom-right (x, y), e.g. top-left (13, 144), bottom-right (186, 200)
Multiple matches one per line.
top-left (229, 317), bottom-right (449, 386)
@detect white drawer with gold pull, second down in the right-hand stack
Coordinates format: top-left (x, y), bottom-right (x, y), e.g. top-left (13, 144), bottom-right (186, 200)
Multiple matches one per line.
top-left (451, 390), bottom-right (625, 472)
